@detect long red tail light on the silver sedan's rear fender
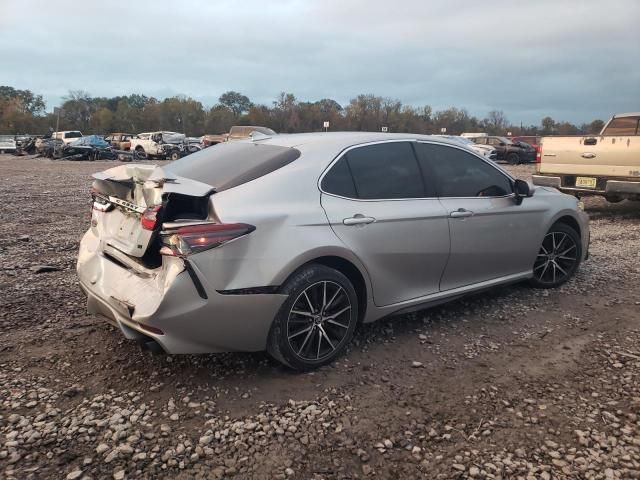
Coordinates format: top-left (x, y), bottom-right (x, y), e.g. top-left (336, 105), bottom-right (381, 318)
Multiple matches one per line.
top-left (160, 223), bottom-right (256, 256)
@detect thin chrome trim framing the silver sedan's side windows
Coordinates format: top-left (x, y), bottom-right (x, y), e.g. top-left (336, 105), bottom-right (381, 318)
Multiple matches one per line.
top-left (317, 138), bottom-right (515, 202)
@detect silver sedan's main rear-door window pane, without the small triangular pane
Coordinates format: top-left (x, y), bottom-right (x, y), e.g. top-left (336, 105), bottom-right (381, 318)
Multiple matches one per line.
top-left (347, 142), bottom-right (425, 199)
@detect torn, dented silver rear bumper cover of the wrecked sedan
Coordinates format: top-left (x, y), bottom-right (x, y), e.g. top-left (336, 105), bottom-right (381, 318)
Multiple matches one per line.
top-left (77, 230), bottom-right (287, 354)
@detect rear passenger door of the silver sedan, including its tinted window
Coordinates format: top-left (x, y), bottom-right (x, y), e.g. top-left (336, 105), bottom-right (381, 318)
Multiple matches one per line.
top-left (320, 141), bottom-right (449, 306)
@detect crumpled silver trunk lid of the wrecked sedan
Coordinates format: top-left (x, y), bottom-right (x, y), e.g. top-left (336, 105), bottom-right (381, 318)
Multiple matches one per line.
top-left (91, 164), bottom-right (213, 257)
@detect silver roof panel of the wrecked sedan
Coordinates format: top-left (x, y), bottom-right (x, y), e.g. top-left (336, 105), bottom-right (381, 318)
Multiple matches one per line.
top-left (250, 132), bottom-right (460, 149)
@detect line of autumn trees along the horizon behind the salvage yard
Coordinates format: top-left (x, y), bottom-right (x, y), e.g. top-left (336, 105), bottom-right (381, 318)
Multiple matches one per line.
top-left (0, 86), bottom-right (603, 136)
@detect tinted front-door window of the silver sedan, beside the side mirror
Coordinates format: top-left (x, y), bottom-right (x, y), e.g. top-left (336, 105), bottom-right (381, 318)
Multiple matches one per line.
top-left (416, 143), bottom-right (513, 197)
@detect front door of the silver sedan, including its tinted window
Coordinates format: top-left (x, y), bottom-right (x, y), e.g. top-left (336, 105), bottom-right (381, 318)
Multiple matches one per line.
top-left (416, 143), bottom-right (546, 291)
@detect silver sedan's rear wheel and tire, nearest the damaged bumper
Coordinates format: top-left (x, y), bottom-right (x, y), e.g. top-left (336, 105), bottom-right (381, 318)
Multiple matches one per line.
top-left (267, 264), bottom-right (358, 371)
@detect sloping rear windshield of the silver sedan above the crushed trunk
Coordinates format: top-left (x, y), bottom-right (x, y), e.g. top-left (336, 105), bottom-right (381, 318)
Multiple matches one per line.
top-left (168, 142), bottom-right (300, 192)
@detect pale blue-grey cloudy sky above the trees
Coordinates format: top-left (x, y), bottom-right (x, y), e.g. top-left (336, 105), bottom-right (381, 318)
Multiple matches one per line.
top-left (0, 0), bottom-right (640, 124)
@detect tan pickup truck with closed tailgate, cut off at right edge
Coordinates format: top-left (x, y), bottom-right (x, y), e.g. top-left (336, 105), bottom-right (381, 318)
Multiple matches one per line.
top-left (533, 112), bottom-right (640, 202)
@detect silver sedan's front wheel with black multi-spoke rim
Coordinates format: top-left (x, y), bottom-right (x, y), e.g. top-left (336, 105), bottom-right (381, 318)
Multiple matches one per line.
top-left (531, 223), bottom-right (582, 288)
